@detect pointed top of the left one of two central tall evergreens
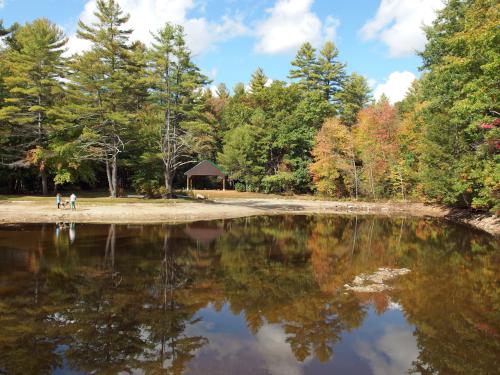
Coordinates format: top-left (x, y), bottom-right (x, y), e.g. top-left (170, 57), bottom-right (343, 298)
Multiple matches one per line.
top-left (288, 42), bottom-right (318, 91)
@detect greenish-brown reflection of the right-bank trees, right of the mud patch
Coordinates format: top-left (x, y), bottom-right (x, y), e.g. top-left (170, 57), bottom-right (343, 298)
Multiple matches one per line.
top-left (394, 222), bottom-right (500, 374)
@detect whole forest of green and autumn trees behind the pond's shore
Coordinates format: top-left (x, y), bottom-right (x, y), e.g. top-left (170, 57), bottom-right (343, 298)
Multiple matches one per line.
top-left (0, 0), bottom-right (500, 212)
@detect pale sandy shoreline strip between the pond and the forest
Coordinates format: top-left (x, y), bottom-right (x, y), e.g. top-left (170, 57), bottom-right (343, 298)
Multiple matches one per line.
top-left (0, 197), bottom-right (500, 236)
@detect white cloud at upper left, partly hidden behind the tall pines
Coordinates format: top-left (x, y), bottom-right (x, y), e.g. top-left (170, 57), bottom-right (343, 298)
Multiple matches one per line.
top-left (65, 0), bottom-right (247, 55)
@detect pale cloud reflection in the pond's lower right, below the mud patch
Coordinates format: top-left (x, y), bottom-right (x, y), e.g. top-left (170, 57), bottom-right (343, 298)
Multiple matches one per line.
top-left (355, 326), bottom-right (418, 375)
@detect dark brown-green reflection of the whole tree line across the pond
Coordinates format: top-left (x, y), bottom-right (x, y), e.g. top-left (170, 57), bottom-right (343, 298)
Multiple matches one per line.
top-left (0, 216), bottom-right (500, 374)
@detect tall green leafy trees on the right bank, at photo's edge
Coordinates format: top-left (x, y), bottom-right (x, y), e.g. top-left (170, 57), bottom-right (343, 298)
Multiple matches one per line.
top-left (421, 0), bottom-right (500, 208)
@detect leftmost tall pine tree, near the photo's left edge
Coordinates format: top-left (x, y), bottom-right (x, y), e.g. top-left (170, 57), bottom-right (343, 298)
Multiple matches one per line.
top-left (0, 19), bottom-right (67, 195)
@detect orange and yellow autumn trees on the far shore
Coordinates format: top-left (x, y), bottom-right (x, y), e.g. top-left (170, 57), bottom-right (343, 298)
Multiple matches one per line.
top-left (310, 98), bottom-right (407, 199)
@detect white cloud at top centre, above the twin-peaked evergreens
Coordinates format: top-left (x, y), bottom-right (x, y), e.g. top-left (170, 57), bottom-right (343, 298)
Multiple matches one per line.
top-left (255, 0), bottom-right (339, 54)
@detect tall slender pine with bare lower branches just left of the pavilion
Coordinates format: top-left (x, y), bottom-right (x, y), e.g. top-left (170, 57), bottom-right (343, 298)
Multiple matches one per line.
top-left (150, 23), bottom-right (208, 195)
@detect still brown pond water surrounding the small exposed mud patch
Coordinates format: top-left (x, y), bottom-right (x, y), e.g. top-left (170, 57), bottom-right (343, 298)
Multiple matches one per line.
top-left (0, 216), bottom-right (500, 375)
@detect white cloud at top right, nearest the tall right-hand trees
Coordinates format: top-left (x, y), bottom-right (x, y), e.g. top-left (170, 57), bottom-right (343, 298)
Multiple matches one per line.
top-left (360, 0), bottom-right (444, 57)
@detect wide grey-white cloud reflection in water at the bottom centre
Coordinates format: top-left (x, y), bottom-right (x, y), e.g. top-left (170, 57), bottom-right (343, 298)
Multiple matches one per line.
top-left (194, 324), bottom-right (311, 375)
